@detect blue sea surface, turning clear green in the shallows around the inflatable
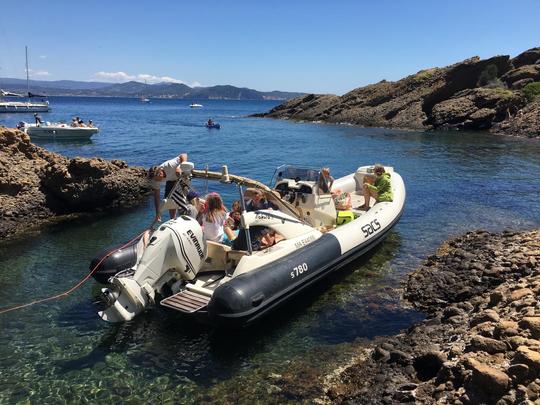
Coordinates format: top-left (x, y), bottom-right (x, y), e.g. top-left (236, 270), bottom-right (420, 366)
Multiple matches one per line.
top-left (0, 97), bottom-right (540, 404)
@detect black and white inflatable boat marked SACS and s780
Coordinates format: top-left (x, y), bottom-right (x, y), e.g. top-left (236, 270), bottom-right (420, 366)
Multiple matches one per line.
top-left (91, 162), bottom-right (405, 325)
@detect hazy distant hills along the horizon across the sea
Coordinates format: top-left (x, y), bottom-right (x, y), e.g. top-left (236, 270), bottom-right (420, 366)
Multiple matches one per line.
top-left (0, 78), bottom-right (304, 100)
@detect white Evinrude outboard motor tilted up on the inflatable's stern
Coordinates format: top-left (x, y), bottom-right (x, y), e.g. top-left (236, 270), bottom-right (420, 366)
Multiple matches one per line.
top-left (99, 215), bottom-right (206, 322)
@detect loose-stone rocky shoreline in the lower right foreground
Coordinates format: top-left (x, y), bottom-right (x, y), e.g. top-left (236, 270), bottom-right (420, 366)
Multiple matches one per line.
top-left (318, 229), bottom-right (540, 405)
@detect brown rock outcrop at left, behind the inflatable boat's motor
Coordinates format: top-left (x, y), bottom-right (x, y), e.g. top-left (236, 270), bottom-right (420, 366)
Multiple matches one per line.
top-left (0, 127), bottom-right (149, 239)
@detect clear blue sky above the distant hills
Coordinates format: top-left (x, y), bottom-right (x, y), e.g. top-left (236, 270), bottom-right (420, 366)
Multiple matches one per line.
top-left (0, 0), bottom-right (540, 94)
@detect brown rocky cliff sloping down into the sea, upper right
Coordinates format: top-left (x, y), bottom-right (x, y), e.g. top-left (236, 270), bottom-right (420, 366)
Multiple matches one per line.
top-left (257, 48), bottom-right (540, 137)
